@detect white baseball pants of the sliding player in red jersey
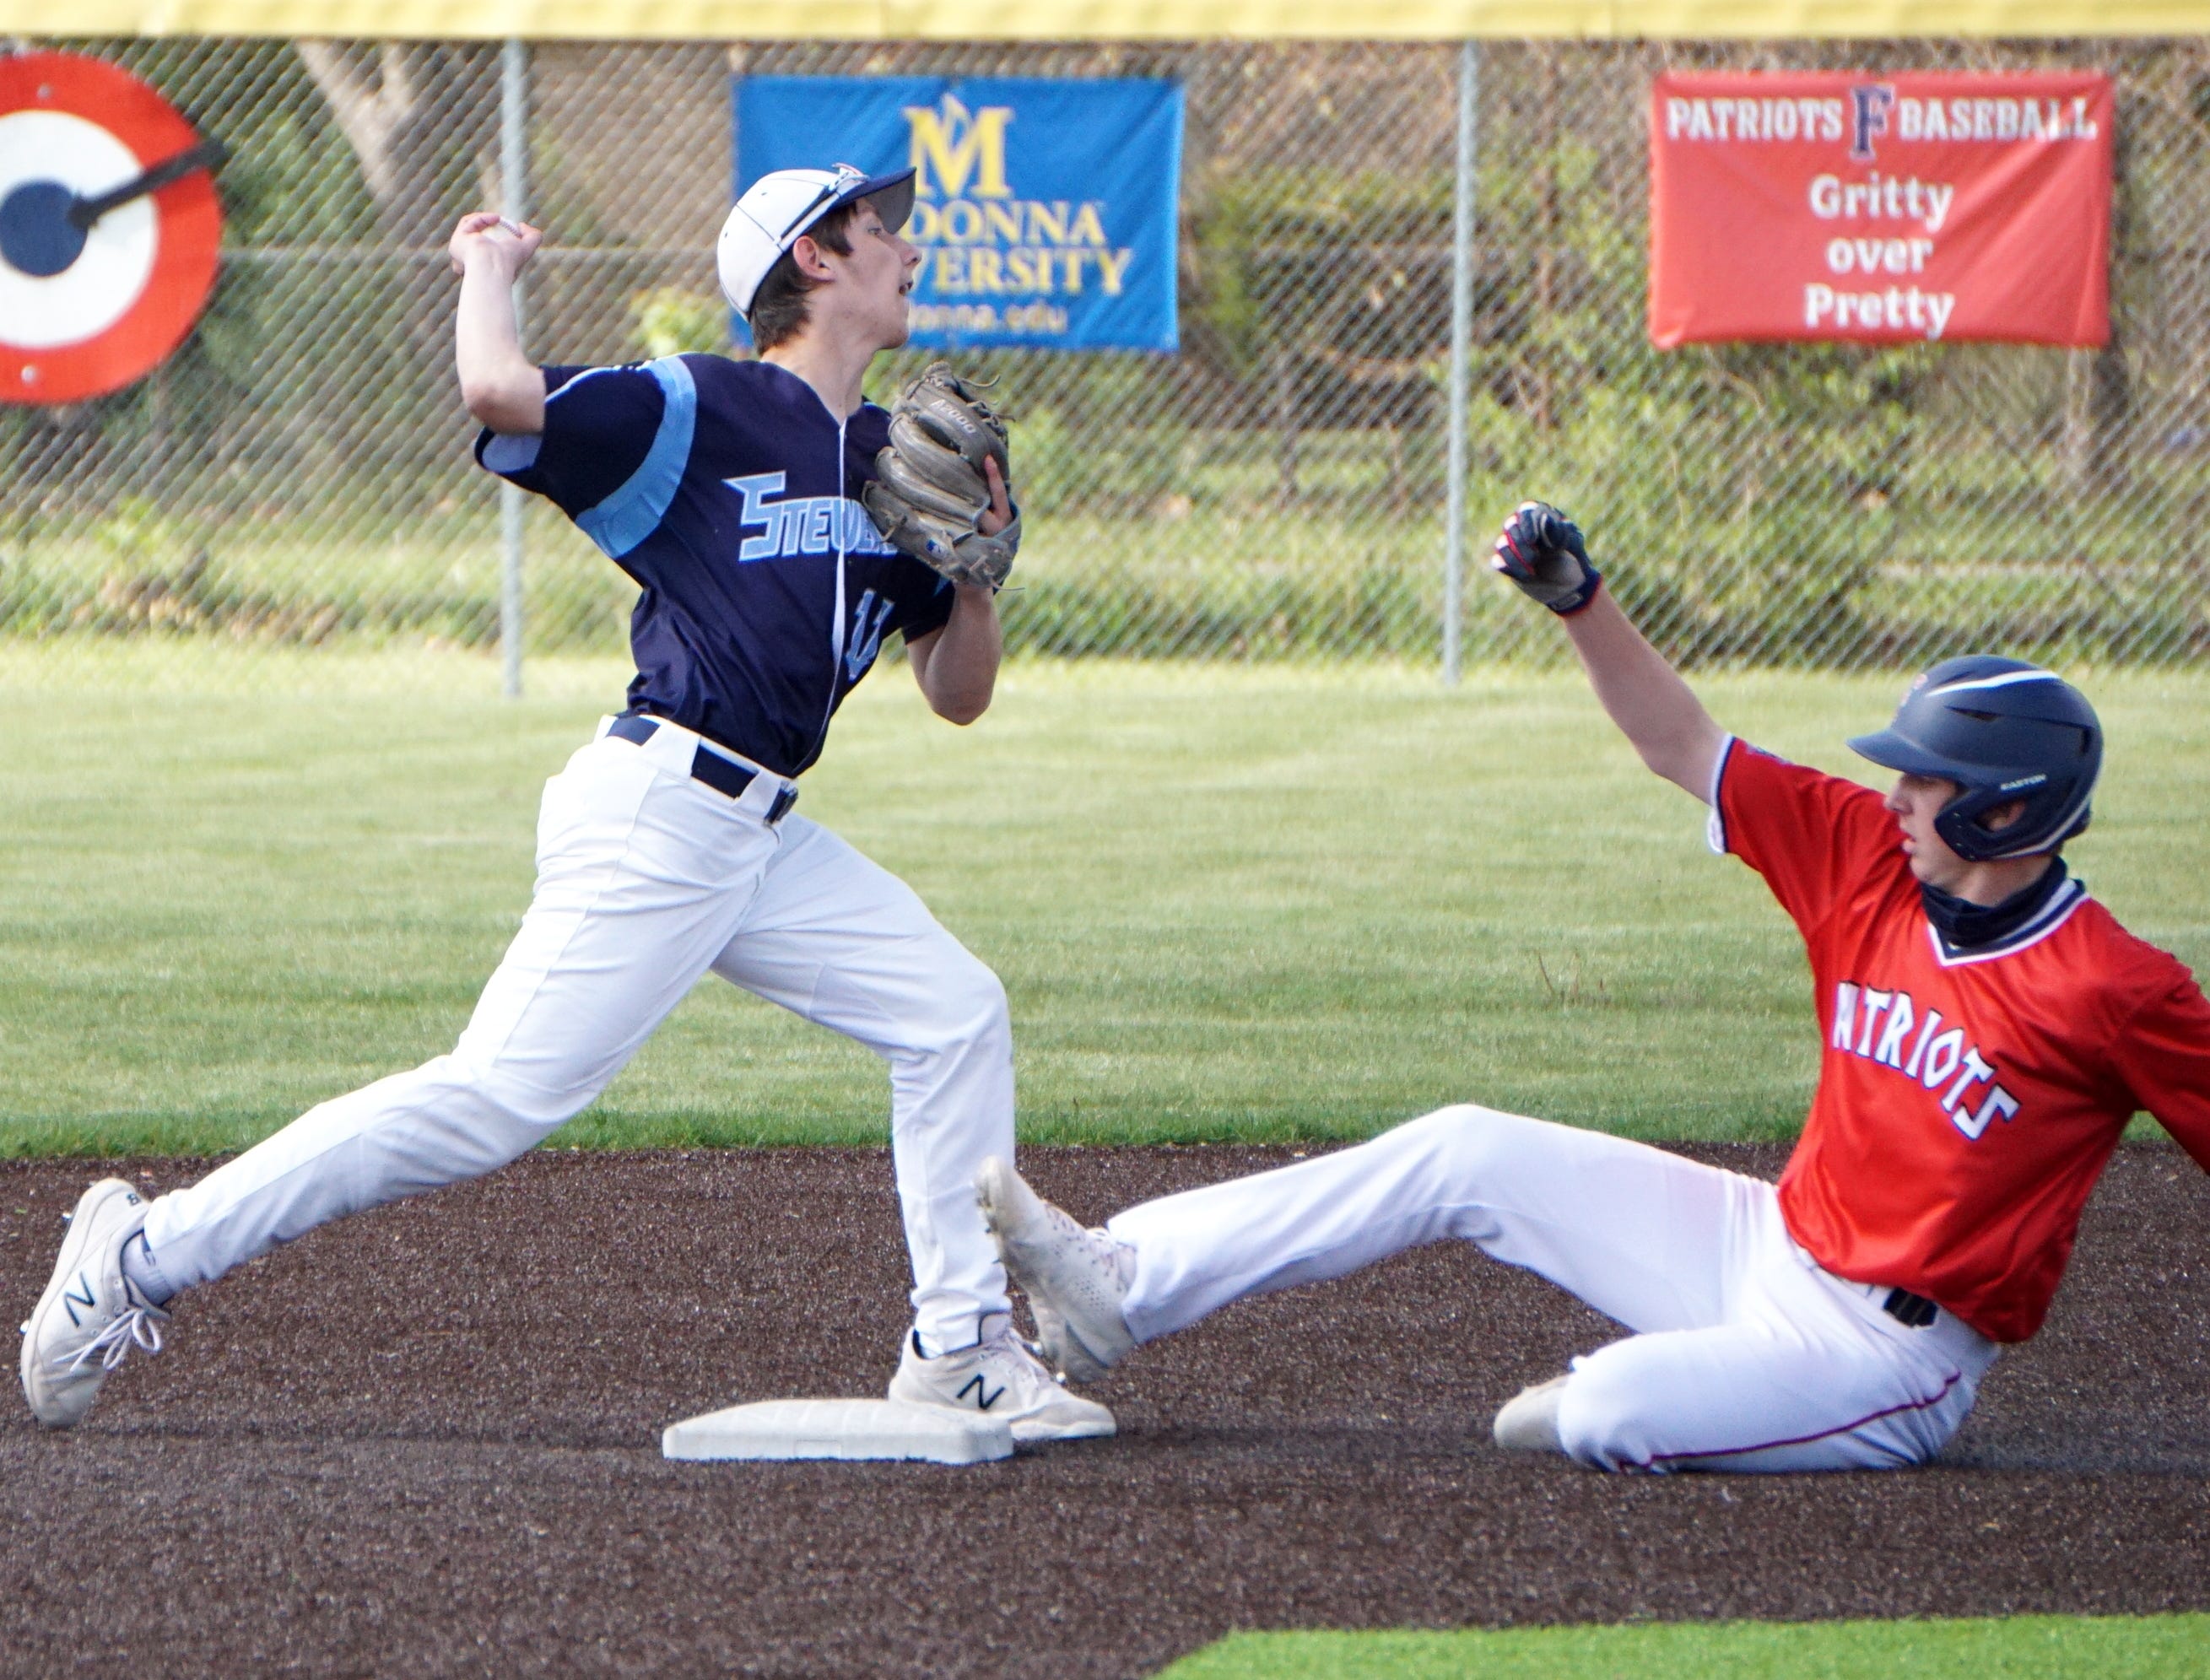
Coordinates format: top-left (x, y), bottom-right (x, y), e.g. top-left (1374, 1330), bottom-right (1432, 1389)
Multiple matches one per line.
top-left (1105, 1107), bottom-right (1996, 1470)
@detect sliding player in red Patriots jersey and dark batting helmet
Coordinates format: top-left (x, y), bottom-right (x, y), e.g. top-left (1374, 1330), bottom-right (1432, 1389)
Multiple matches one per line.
top-left (977, 502), bottom-right (2210, 1470)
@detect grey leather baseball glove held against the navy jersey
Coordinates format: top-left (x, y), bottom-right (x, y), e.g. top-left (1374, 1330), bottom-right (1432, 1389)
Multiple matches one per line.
top-left (860, 363), bottom-right (1021, 590)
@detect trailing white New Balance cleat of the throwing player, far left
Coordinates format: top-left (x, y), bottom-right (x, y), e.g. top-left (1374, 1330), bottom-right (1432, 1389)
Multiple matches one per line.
top-left (20, 1178), bottom-right (168, 1430)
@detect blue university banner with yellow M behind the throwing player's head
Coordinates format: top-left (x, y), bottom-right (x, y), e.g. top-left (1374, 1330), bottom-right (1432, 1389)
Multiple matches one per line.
top-left (734, 75), bottom-right (1182, 349)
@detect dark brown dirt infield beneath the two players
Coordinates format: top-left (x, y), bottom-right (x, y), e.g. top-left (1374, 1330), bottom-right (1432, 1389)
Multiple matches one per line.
top-left (0, 1145), bottom-right (2210, 1676)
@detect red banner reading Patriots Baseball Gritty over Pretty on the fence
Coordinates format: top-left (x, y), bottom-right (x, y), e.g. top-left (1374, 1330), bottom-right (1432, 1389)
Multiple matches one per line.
top-left (1649, 73), bottom-right (2115, 347)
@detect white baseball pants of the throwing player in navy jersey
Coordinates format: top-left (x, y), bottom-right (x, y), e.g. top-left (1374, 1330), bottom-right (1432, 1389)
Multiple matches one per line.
top-left (146, 723), bottom-right (1013, 1353)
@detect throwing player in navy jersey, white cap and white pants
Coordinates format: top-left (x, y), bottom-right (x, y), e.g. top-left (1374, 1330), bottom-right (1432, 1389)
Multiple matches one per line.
top-left (22, 165), bottom-right (1114, 1441)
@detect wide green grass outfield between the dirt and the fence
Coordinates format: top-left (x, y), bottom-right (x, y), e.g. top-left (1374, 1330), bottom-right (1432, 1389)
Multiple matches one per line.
top-left (0, 648), bottom-right (2210, 1154)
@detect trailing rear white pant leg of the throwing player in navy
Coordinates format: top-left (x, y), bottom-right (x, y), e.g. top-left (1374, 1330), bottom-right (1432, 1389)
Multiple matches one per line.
top-left (146, 738), bottom-right (775, 1288)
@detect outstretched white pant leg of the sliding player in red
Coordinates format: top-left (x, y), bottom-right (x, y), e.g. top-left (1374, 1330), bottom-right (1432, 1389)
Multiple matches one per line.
top-left (1105, 1105), bottom-right (1770, 1342)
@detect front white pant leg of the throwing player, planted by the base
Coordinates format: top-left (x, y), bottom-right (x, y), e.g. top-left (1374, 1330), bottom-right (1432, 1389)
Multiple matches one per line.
top-left (714, 816), bottom-right (1013, 1353)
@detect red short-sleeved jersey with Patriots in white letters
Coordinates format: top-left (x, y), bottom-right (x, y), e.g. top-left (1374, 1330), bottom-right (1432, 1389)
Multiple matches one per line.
top-left (1713, 741), bottom-right (2210, 1342)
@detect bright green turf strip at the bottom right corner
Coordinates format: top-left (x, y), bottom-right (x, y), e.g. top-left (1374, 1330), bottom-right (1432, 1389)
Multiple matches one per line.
top-left (1160, 1616), bottom-right (2210, 1680)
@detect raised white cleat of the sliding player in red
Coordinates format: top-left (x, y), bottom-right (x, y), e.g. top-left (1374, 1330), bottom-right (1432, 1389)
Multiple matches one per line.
top-left (975, 1156), bottom-right (1136, 1381)
